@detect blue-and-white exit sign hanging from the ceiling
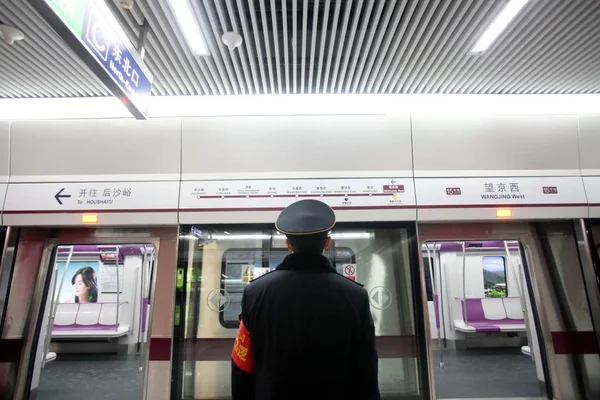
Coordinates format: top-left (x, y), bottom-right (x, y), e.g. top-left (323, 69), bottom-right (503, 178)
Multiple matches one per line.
top-left (29, 0), bottom-right (152, 119)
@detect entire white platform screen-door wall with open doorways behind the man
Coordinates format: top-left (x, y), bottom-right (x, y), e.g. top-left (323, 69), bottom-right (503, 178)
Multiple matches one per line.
top-left (0, 114), bottom-right (600, 399)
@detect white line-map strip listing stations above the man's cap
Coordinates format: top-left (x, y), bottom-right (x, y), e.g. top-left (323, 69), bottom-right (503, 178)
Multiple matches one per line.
top-left (180, 178), bottom-right (415, 212)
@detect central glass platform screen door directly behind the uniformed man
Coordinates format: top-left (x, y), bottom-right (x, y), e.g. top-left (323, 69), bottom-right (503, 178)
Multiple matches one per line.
top-left (172, 223), bottom-right (427, 399)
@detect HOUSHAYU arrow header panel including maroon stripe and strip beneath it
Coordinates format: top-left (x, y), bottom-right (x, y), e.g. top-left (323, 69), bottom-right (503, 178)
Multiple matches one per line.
top-left (3, 181), bottom-right (179, 226)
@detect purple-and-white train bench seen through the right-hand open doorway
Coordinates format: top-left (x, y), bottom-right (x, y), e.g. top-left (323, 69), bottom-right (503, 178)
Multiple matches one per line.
top-left (454, 298), bottom-right (526, 333)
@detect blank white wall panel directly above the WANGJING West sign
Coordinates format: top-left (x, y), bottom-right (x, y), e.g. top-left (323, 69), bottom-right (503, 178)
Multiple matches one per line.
top-left (412, 115), bottom-right (579, 177)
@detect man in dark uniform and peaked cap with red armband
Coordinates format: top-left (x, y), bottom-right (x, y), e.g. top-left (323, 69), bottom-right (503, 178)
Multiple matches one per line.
top-left (231, 200), bottom-right (380, 400)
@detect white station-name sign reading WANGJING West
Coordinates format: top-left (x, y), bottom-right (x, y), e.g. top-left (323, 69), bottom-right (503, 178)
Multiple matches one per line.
top-left (415, 177), bottom-right (586, 208)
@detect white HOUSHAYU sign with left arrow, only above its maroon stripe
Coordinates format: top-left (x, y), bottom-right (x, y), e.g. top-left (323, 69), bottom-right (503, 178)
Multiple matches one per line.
top-left (4, 182), bottom-right (179, 214)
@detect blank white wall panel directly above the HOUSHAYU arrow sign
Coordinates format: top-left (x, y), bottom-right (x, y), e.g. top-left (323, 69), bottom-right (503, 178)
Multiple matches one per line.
top-left (10, 120), bottom-right (181, 182)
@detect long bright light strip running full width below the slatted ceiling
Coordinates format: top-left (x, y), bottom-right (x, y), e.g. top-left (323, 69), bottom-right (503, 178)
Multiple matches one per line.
top-left (0, 94), bottom-right (600, 121)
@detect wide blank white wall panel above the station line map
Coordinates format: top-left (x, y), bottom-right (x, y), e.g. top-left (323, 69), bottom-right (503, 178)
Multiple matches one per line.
top-left (182, 115), bottom-right (412, 180)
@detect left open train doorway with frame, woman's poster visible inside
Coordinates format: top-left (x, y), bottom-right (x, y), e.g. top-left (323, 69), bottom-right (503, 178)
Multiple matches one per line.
top-left (0, 226), bottom-right (178, 399)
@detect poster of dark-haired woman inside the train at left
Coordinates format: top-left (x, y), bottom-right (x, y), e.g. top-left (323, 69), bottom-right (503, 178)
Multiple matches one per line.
top-left (56, 261), bottom-right (100, 303)
